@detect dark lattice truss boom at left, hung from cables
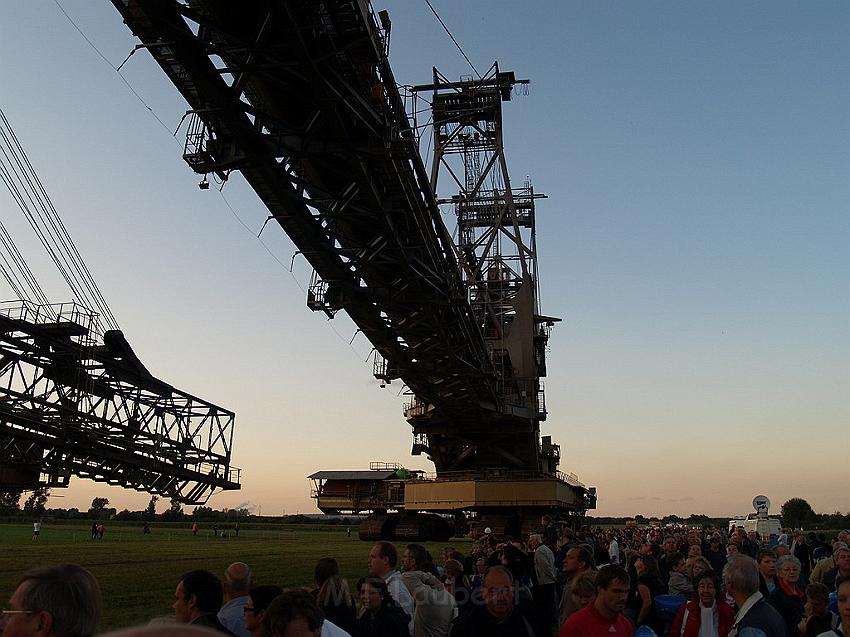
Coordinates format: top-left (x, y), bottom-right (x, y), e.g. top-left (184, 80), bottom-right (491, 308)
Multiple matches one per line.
top-left (0, 302), bottom-right (239, 503)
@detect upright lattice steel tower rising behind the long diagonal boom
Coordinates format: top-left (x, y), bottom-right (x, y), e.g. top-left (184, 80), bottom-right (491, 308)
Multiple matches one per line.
top-left (406, 63), bottom-right (559, 472)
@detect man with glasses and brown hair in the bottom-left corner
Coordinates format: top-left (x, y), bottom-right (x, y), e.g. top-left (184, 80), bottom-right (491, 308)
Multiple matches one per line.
top-left (0, 564), bottom-right (100, 637)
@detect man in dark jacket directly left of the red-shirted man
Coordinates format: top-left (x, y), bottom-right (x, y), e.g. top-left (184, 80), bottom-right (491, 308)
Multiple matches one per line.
top-left (449, 566), bottom-right (536, 637)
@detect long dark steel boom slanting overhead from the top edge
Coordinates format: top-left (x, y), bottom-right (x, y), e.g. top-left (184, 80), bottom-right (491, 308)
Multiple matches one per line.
top-left (108, 0), bottom-right (502, 422)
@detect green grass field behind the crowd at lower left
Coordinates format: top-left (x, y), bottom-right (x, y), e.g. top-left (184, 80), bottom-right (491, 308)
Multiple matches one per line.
top-left (0, 524), bottom-right (469, 631)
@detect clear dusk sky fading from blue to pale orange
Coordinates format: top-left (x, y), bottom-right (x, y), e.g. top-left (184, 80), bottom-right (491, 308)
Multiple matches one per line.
top-left (0, 0), bottom-right (850, 515)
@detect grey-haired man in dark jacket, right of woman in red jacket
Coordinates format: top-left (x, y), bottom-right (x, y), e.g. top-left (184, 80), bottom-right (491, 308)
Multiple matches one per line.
top-left (723, 554), bottom-right (788, 637)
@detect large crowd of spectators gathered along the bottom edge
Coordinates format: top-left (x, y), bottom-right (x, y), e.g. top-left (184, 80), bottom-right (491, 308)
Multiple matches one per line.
top-left (0, 516), bottom-right (850, 637)
